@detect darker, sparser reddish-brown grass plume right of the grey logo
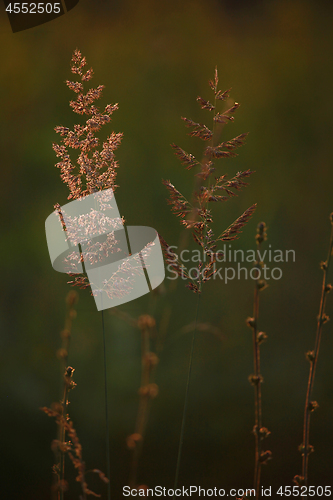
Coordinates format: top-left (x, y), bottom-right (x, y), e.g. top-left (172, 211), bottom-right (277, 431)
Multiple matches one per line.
top-left (160, 68), bottom-right (256, 293)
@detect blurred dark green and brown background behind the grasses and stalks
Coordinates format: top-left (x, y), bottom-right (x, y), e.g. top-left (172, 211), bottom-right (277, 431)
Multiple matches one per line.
top-left (0, 0), bottom-right (333, 500)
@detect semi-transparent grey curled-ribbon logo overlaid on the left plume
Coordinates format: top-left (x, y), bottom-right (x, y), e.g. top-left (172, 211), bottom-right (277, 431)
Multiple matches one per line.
top-left (45, 189), bottom-right (165, 311)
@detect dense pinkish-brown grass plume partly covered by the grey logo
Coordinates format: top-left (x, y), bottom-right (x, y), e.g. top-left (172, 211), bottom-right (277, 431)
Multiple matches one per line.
top-left (53, 49), bottom-right (153, 304)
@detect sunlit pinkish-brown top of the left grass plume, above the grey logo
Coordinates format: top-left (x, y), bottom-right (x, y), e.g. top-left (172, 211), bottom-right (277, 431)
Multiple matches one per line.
top-left (53, 49), bottom-right (124, 291)
